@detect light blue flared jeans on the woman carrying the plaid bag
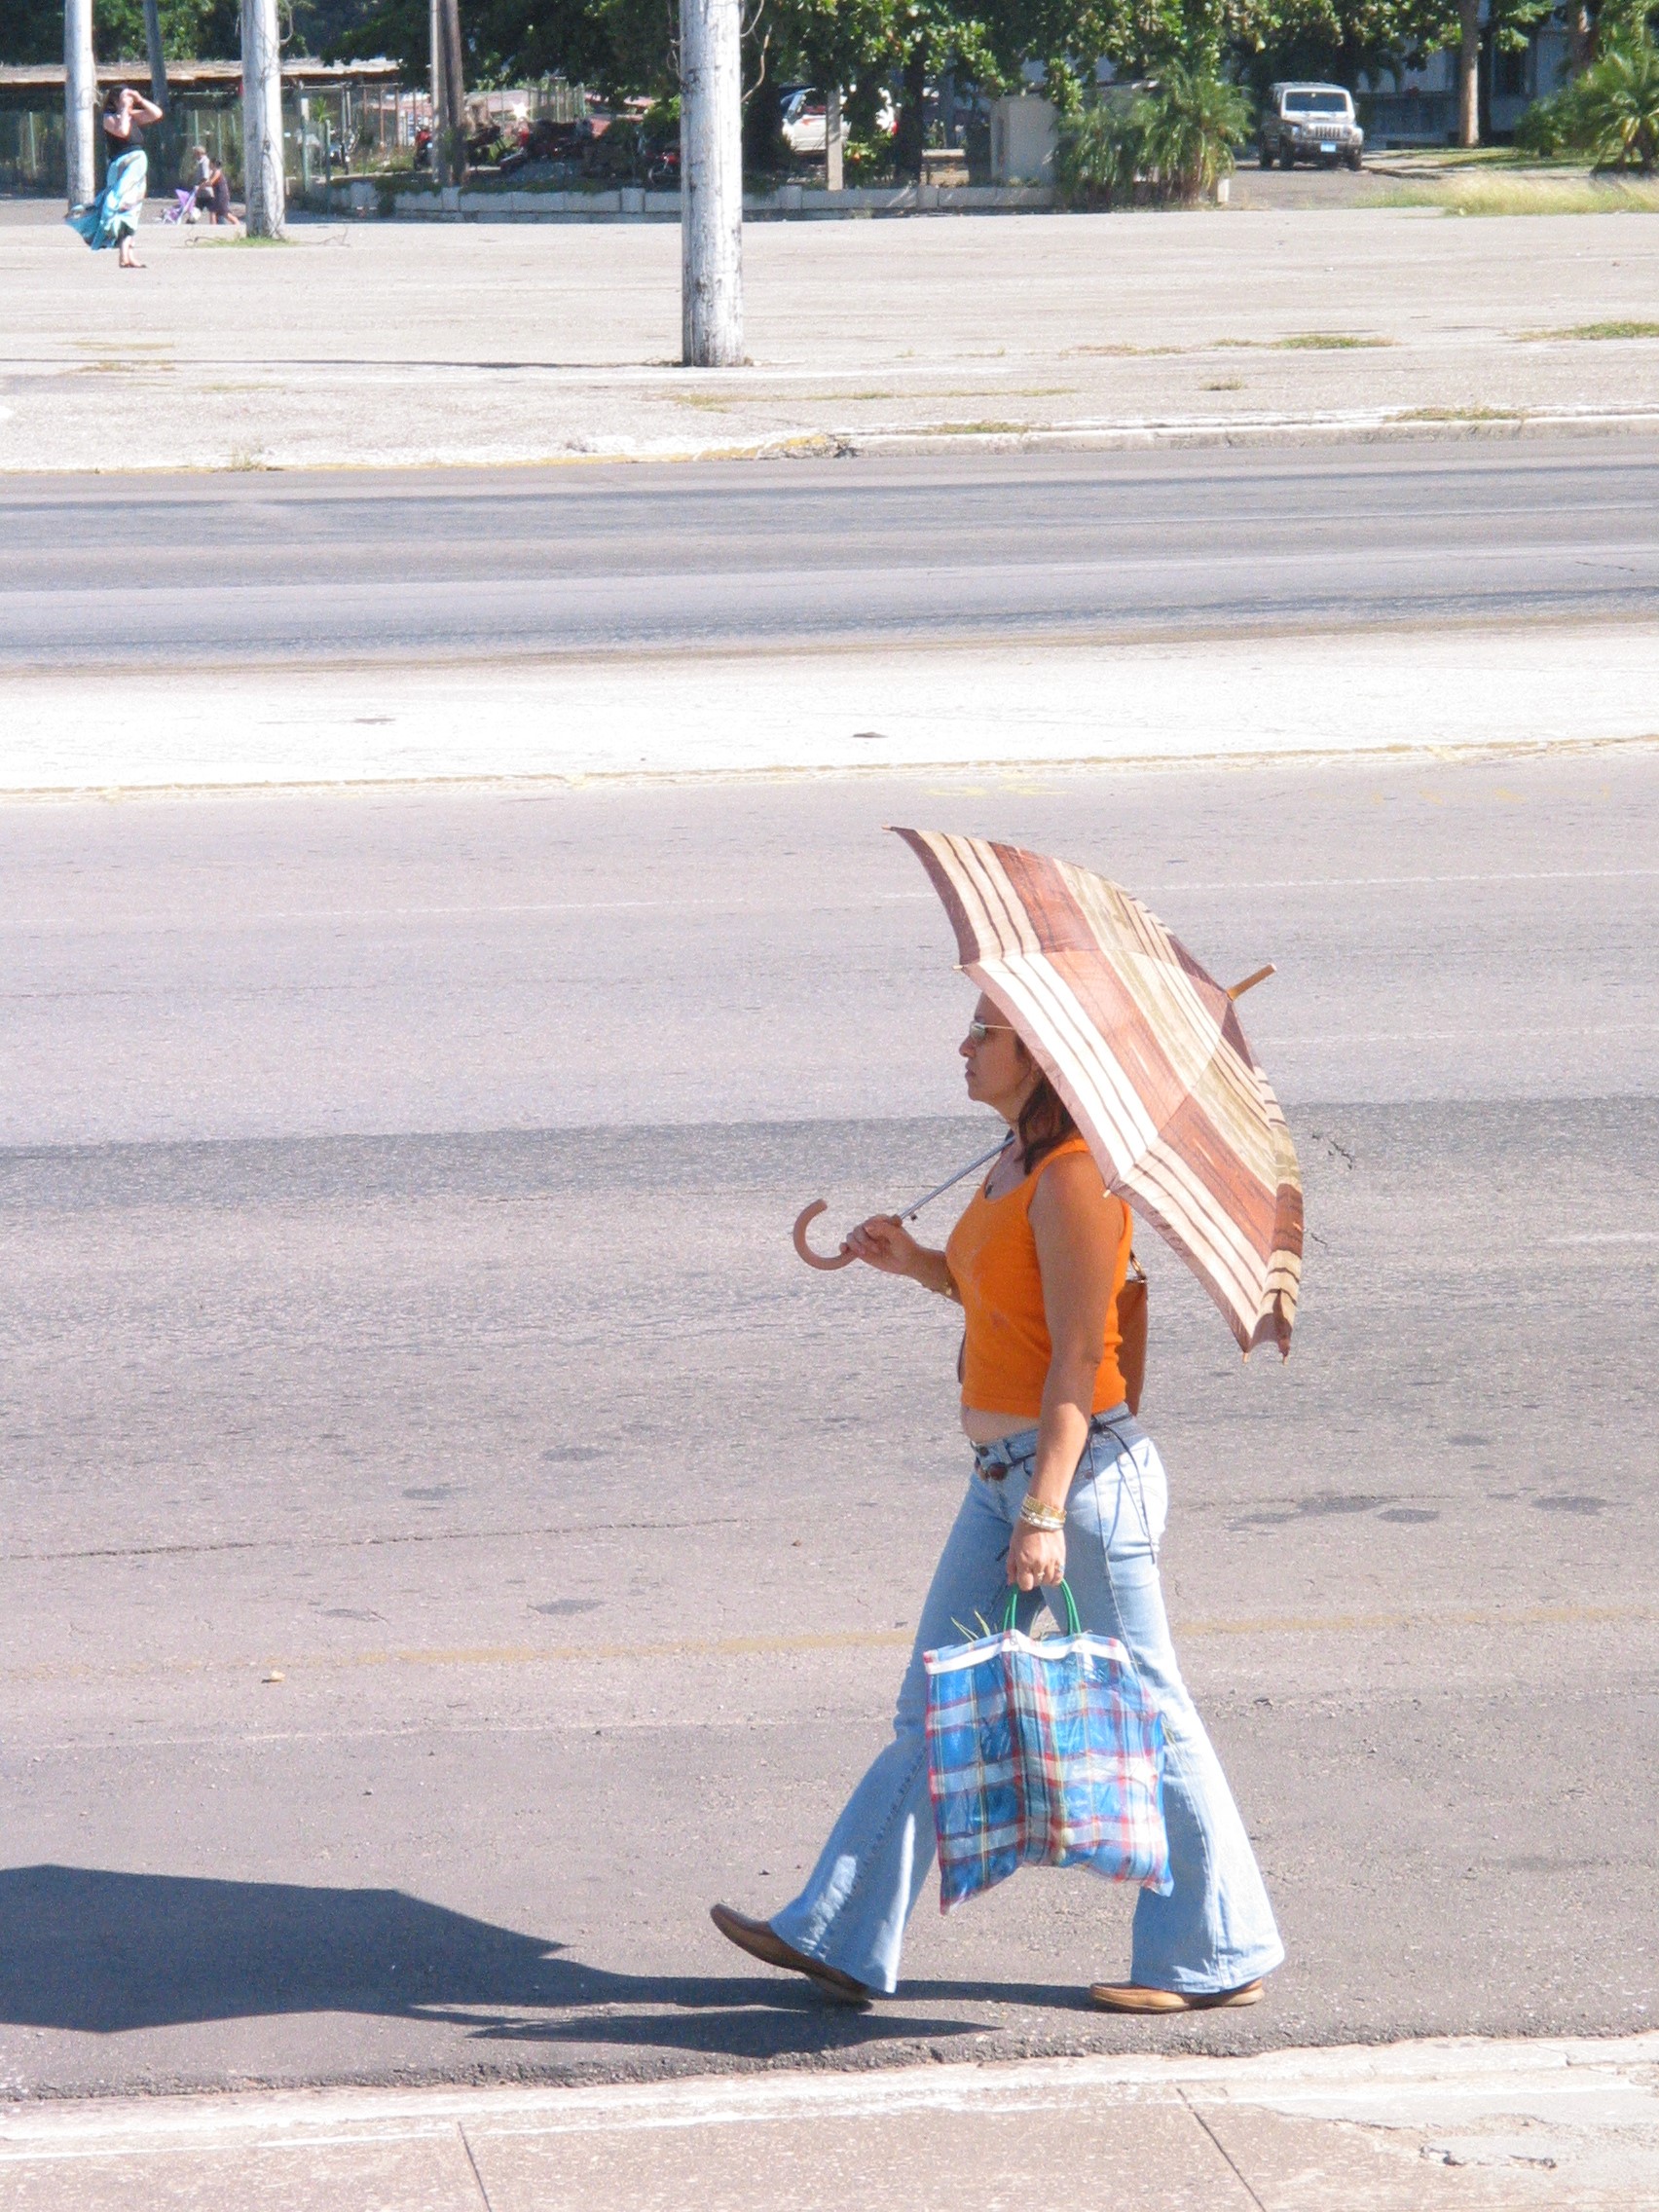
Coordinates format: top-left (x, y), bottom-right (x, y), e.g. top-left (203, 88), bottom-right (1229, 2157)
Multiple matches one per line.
top-left (772, 1407), bottom-right (1285, 1995)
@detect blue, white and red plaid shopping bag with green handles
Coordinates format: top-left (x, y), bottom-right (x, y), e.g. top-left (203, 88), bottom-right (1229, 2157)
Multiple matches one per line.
top-left (922, 1581), bottom-right (1172, 1913)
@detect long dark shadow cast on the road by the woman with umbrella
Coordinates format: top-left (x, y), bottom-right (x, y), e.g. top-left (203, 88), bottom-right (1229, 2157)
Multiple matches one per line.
top-left (0, 1867), bottom-right (1087, 2055)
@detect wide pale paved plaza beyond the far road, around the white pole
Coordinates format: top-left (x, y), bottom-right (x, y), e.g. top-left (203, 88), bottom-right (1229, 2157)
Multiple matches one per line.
top-left (0, 202), bottom-right (1659, 469)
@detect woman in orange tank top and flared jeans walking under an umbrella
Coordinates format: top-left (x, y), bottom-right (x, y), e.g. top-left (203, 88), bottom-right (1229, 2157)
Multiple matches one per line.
top-left (713, 998), bottom-right (1285, 2013)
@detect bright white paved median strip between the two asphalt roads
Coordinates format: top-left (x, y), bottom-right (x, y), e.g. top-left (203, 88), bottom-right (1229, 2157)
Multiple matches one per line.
top-left (13, 621), bottom-right (1659, 796)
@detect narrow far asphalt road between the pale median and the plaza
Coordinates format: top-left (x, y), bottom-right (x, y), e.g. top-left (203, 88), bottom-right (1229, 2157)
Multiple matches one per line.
top-left (0, 438), bottom-right (1659, 668)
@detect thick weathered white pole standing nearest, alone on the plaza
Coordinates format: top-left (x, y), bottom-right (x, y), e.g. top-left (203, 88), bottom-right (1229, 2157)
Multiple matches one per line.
top-left (680, 0), bottom-right (743, 369)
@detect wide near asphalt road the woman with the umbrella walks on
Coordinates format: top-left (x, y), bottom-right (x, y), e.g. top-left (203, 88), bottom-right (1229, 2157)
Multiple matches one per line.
top-left (0, 748), bottom-right (1659, 2090)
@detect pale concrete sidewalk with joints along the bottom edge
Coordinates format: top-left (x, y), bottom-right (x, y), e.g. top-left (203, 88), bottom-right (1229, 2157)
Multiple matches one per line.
top-left (0, 2033), bottom-right (1659, 2212)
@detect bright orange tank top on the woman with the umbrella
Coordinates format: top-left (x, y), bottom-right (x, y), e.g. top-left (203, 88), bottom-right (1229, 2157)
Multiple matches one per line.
top-left (944, 1137), bottom-right (1132, 1420)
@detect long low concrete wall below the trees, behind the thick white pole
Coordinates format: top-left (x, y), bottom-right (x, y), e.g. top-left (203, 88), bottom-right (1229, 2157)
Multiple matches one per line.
top-left (343, 177), bottom-right (1055, 223)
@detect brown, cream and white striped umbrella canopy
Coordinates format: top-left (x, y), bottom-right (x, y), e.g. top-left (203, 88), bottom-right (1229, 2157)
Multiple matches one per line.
top-left (898, 830), bottom-right (1303, 1353)
